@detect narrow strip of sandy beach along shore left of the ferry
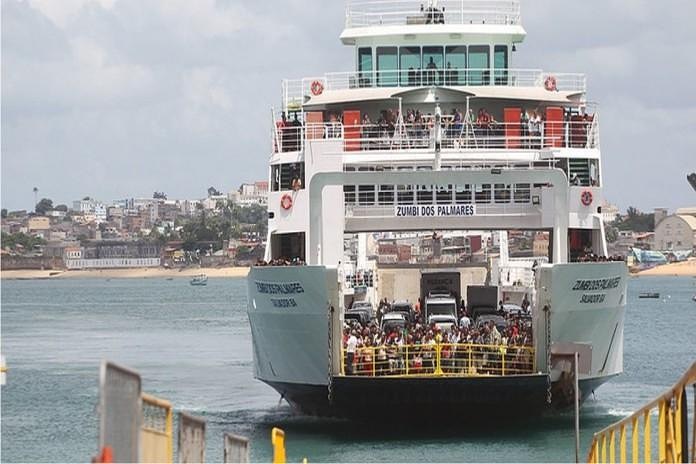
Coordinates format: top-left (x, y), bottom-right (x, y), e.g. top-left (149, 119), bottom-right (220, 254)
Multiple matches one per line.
top-left (0, 267), bottom-right (249, 279)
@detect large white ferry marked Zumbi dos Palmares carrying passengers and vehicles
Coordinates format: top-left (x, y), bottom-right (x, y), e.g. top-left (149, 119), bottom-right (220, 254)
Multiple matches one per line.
top-left (248, 0), bottom-right (627, 420)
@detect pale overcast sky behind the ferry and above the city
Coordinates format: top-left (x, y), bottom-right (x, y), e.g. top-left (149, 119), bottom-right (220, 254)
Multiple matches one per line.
top-left (2, 0), bottom-right (696, 210)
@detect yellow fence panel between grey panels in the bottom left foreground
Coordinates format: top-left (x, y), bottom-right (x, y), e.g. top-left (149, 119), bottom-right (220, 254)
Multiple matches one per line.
top-left (140, 393), bottom-right (174, 463)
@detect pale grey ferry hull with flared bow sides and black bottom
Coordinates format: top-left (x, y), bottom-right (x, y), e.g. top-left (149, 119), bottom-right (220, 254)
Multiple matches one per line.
top-left (248, 263), bottom-right (627, 416)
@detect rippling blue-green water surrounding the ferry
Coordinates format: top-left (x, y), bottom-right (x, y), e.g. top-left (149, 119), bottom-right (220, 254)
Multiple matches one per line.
top-left (1, 277), bottom-right (696, 462)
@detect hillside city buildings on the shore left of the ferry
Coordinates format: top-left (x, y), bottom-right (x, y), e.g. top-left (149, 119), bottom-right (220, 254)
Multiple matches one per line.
top-left (2, 181), bottom-right (268, 269)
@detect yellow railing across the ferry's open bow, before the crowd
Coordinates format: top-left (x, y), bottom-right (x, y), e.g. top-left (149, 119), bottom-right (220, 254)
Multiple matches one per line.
top-left (341, 343), bottom-right (536, 377)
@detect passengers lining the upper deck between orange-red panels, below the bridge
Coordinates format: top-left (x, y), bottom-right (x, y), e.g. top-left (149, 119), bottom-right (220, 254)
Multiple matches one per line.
top-left (277, 107), bottom-right (593, 151)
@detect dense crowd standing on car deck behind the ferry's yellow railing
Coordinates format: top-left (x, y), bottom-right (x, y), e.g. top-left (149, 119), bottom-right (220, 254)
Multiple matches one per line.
top-left (343, 301), bottom-right (533, 376)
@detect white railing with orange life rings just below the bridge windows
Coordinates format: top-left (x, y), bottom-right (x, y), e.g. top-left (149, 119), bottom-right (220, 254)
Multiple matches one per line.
top-left (282, 68), bottom-right (587, 110)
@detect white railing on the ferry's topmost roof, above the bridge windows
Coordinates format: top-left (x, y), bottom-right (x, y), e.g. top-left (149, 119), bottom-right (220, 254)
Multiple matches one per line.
top-left (346, 0), bottom-right (521, 28)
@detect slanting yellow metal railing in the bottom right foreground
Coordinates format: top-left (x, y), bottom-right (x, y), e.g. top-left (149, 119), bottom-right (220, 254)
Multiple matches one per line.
top-left (587, 363), bottom-right (696, 463)
